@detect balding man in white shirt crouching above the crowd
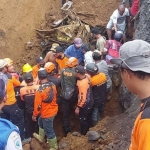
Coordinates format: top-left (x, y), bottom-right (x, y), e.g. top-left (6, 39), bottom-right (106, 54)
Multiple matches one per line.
top-left (106, 5), bottom-right (131, 42)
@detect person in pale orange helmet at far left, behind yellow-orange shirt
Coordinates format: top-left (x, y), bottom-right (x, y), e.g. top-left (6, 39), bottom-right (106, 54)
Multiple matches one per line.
top-left (4, 58), bottom-right (20, 80)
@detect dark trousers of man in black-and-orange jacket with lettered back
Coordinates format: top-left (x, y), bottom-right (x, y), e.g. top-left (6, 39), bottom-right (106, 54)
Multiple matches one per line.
top-left (26, 113), bottom-right (36, 138)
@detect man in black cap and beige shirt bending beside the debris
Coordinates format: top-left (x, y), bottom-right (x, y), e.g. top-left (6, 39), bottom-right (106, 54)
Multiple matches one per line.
top-left (91, 27), bottom-right (106, 52)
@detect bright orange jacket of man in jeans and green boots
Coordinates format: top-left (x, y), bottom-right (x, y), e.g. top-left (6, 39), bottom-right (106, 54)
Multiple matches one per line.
top-left (33, 84), bottom-right (58, 118)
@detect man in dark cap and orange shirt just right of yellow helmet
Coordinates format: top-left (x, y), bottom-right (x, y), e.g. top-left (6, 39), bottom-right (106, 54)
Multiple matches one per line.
top-left (32, 57), bottom-right (45, 79)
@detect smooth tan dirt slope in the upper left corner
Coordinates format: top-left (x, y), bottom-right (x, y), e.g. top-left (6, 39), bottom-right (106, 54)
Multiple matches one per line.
top-left (0, 0), bottom-right (59, 69)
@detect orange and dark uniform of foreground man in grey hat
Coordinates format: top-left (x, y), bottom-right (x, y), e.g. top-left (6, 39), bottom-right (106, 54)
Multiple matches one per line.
top-left (129, 97), bottom-right (150, 150)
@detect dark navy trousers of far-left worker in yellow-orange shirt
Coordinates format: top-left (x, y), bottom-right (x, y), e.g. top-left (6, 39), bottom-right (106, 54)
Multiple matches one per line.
top-left (0, 103), bottom-right (25, 140)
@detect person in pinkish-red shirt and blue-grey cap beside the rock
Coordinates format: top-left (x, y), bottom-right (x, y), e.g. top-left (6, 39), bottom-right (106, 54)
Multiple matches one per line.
top-left (103, 31), bottom-right (123, 64)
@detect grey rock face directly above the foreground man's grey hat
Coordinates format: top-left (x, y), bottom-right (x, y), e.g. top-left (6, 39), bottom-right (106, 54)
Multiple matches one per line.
top-left (135, 0), bottom-right (150, 43)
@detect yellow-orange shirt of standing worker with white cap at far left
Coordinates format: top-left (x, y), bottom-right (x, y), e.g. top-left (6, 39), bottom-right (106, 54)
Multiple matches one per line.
top-left (5, 73), bottom-right (20, 105)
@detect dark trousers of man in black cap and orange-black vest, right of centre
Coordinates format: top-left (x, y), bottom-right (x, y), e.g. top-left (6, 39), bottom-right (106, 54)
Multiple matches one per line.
top-left (79, 101), bottom-right (93, 135)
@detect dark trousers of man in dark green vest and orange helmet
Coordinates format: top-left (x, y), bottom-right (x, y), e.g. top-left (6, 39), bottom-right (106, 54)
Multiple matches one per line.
top-left (62, 98), bottom-right (77, 134)
